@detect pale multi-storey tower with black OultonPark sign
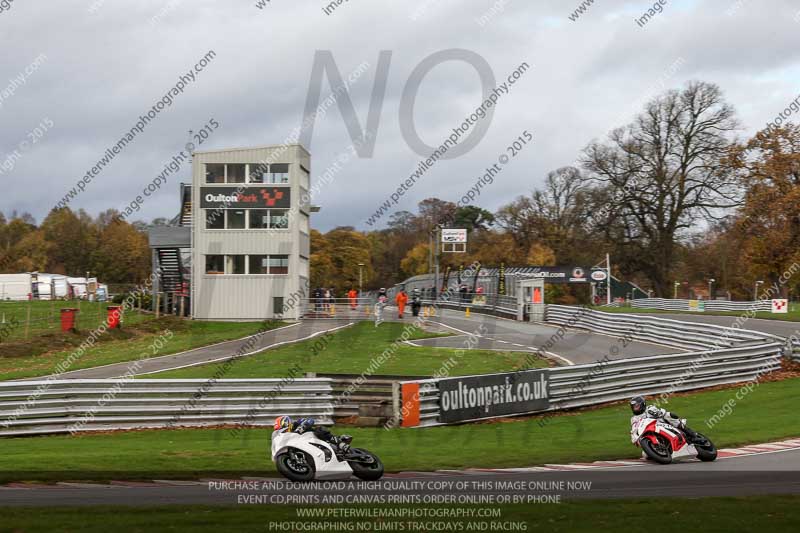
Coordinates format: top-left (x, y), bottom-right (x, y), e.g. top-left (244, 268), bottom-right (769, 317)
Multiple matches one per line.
top-left (191, 145), bottom-right (311, 320)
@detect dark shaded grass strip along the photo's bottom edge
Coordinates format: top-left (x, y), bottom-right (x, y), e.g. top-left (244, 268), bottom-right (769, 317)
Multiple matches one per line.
top-left (0, 496), bottom-right (800, 533)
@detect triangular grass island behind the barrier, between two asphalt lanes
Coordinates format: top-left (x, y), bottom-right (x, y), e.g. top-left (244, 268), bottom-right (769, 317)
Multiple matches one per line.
top-left (142, 322), bottom-right (547, 378)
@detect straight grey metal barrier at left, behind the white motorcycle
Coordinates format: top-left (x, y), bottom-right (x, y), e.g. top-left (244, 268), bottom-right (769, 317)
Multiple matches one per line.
top-left (0, 379), bottom-right (333, 436)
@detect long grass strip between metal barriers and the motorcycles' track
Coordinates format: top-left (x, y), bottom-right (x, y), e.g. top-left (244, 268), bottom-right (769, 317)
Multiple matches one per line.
top-left (0, 379), bottom-right (800, 481)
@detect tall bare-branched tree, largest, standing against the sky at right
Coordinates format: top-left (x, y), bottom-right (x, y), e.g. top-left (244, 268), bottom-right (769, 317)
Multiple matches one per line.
top-left (583, 82), bottom-right (738, 296)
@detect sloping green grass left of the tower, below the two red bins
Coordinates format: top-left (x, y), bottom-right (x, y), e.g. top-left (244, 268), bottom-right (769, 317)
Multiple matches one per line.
top-left (0, 317), bottom-right (285, 381)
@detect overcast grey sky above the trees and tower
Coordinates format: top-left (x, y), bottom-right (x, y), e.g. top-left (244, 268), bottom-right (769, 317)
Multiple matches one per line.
top-left (0, 0), bottom-right (800, 231)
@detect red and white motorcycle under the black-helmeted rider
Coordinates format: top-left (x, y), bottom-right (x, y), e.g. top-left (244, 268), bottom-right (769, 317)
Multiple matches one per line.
top-left (631, 416), bottom-right (717, 465)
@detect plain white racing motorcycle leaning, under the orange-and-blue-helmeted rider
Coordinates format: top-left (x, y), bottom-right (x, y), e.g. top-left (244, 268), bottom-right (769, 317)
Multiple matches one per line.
top-left (272, 430), bottom-right (383, 481)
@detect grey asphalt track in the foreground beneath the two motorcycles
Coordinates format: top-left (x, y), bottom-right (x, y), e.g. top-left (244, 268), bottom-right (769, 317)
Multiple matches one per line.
top-left (0, 445), bottom-right (800, 506)
